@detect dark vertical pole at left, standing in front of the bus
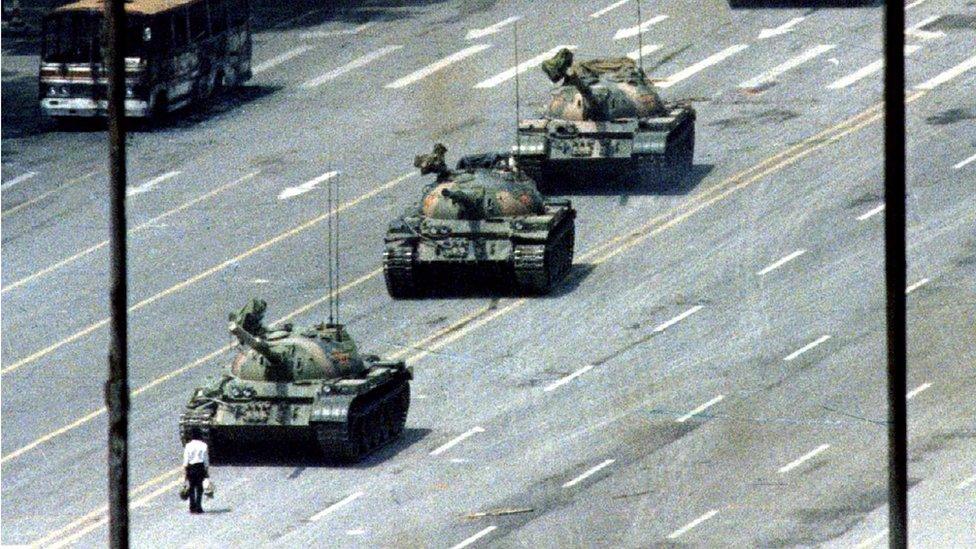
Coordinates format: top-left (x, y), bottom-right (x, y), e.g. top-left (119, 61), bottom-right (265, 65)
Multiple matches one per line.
top-left (103, 0), bottom-right (129, 549)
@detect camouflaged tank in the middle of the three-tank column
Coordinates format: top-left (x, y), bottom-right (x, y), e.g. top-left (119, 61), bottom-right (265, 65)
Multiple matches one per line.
top-left (383, 144), bottom-right (576, 298)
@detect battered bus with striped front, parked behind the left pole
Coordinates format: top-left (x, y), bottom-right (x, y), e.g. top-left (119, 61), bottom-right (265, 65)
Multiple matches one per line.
top-left (38, 0), bottom-right (251, 120)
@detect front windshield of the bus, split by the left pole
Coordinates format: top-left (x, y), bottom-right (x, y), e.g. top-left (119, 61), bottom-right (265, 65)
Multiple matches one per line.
top-left (41, 12), bottom-right (148, 63)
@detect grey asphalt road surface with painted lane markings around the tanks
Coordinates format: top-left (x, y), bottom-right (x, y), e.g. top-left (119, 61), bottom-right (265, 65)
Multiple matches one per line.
top-left (0, 0), bottom-right (976, 547)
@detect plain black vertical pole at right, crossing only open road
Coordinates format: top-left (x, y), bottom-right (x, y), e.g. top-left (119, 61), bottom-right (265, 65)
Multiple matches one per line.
top-left (884, 0), bottom-right (908, 549)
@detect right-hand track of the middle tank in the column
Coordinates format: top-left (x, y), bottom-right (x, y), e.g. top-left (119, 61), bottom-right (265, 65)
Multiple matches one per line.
top-left (513, 220), bottom-right (576, 295)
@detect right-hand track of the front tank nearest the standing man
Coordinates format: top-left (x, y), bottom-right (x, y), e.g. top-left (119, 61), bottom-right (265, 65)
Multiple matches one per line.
top-left (314, 380), bottom-right (410, 462)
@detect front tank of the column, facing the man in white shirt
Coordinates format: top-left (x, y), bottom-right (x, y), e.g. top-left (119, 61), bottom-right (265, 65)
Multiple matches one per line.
top-left (179, 300), bottom-right (413, 462)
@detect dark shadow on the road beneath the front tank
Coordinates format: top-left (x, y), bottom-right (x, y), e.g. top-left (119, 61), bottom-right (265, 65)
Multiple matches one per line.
top-left (211, 427), bottom-right (431, 466)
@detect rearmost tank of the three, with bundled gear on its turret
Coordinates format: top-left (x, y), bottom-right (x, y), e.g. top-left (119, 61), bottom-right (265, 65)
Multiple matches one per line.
top-left (513, 49), bottom-right (696, 186)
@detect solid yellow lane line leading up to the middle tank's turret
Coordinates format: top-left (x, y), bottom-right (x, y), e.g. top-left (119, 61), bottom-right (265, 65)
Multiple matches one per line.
top-left (0, 172), bottom-right (415, 374)
